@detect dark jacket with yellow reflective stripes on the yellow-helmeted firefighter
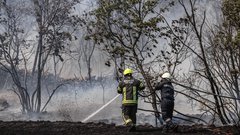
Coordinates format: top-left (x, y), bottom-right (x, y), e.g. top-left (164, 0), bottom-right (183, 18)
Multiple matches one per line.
top-left (117, 76), bottom-right (145, 105)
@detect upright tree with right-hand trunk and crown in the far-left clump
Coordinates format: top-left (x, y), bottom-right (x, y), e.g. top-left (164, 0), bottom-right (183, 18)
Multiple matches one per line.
top-left (32, 0), bottom-right (78, 112)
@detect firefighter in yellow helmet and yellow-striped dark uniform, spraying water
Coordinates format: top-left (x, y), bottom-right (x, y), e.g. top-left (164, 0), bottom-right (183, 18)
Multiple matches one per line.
top-left (117, 68), bottom-right (145, 131)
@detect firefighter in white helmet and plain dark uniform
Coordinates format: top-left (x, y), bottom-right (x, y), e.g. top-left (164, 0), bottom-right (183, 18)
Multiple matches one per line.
top-left (155, 72), bottom-right (177, 132)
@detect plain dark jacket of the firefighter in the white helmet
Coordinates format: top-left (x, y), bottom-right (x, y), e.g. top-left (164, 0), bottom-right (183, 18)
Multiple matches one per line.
top-left (155, 79), bottom-right (174, 100)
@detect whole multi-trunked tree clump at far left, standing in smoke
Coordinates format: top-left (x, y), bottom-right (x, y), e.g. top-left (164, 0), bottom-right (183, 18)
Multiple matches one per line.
top-left (0, 0), bottom-right (80, 113)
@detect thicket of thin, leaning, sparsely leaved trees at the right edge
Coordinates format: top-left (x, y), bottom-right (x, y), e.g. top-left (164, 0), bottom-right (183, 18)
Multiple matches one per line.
top-left (166, 0), bottom-right (239, 124)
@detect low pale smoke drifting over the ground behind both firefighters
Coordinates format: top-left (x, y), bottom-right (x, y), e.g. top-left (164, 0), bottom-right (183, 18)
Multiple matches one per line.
top-left (0, 77), bottom-right (202, 125)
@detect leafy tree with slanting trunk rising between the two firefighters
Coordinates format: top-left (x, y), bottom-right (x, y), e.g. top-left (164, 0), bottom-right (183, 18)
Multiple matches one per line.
top-left (86, 0), bottom-right (182, 123)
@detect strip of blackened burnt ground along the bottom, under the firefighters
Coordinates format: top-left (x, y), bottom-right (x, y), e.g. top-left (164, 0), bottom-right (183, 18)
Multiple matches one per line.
top-left (0, 121), bottom-right (240, 135)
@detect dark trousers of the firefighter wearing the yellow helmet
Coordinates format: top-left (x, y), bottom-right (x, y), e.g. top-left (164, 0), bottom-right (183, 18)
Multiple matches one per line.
top-left (122, 105), bottom-right (137, 125)
